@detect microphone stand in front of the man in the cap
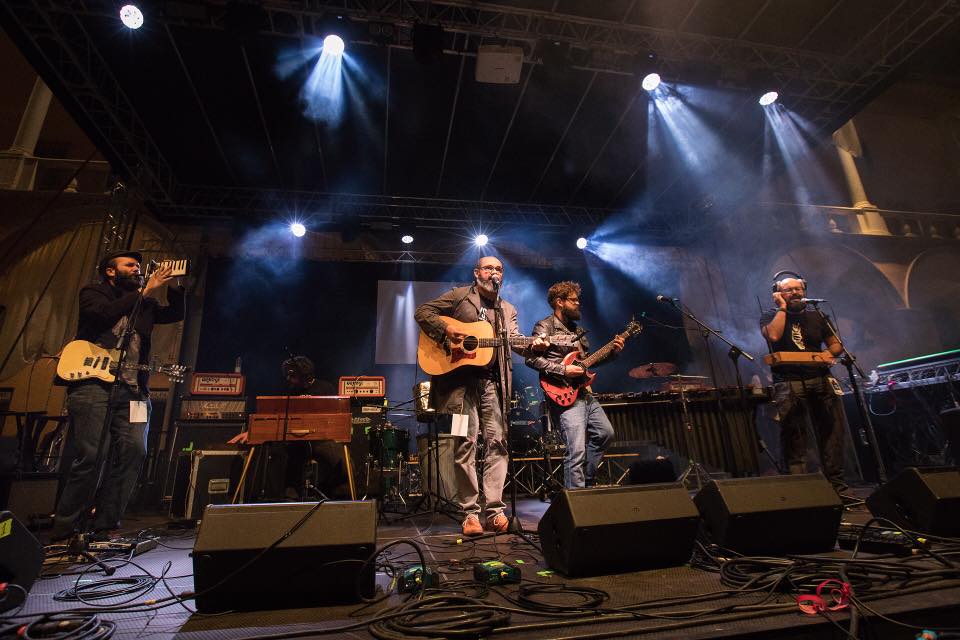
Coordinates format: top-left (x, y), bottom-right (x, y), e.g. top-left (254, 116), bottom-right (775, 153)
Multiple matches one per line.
top-left (67, 262), bottom-right (155, 576)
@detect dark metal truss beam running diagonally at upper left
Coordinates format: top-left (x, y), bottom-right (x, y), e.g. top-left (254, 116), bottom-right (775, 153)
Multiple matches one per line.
top-left (0, 0), bottom-right (176, 204)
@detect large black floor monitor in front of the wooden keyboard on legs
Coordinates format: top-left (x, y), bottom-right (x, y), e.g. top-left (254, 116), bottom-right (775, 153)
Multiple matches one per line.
top-left (193, 501), bottom-right (377, 613)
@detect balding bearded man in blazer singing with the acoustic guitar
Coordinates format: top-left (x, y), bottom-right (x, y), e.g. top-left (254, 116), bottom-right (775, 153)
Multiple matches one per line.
top-left (414, 256), bottom-right (546, 536)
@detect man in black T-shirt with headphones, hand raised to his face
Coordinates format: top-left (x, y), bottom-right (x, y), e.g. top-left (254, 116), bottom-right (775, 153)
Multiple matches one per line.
top-left (760, 271), bottom-right (846, 493)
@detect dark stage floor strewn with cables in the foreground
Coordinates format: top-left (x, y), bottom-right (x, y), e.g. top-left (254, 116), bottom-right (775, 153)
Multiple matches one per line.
top-left (20, 499), bottom-right (960, 640)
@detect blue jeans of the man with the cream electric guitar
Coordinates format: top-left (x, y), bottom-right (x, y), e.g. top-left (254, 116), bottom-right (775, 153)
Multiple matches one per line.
top-left (51, 382), bottom-right (151, 538)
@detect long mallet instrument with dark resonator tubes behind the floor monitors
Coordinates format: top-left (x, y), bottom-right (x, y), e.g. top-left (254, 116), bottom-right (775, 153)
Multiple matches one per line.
top-left (596, 387), bottom-right (770, 476)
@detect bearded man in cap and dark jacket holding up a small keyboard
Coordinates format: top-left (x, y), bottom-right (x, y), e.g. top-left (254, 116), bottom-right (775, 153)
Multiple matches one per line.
top-left (51, 251), bottom-right (184, 540)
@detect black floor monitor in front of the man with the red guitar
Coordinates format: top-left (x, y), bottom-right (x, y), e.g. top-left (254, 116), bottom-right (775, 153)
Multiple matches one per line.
top-left (537, 483), bottom-right (699, 578)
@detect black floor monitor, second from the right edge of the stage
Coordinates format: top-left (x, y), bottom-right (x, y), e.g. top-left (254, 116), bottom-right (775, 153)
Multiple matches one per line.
top-left (693, 473), bottom-right (843, 555)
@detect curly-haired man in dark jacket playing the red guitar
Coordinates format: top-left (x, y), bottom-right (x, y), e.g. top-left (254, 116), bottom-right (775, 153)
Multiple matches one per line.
top-left (527, 281), bottom-right (624, 489)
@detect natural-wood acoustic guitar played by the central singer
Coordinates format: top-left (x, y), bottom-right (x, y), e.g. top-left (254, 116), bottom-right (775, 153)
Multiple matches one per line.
top-left (417, 316), bottom-right (574, 376)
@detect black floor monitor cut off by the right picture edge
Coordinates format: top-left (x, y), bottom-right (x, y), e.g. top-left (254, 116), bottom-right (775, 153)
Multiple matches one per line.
top-left (867, 467), bottom-right (960, 537)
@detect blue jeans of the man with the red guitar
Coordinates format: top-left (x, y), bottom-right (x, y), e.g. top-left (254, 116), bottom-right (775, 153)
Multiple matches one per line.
top-left (550, 391), bottom-right (613, 489)
